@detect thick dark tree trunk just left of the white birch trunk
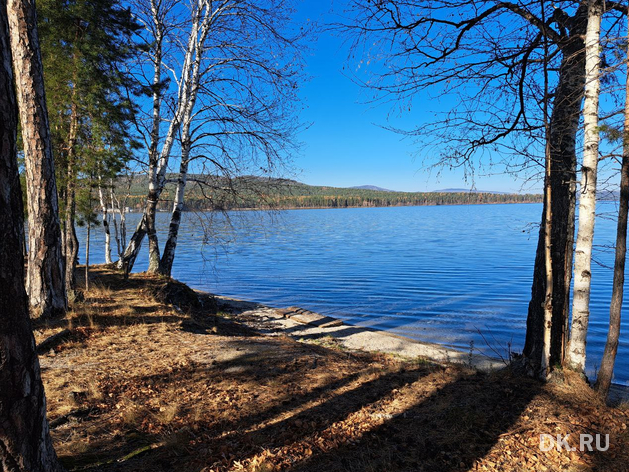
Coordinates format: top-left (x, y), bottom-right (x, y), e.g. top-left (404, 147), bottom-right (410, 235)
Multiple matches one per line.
top-left (524, 3), bottom-right (587, 370)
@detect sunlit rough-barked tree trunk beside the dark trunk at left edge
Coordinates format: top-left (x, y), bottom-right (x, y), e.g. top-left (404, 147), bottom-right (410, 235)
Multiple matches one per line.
top-left (7, 0), bottom-right (67, 317)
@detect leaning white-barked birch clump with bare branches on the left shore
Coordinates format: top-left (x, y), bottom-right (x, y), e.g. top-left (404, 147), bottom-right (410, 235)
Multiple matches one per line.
top-left (119, 0), bottom-right (304, 274)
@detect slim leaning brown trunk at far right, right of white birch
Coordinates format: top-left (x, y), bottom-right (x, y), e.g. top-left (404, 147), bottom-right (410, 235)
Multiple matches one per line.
top-left (595, 13), bottom-right (629, 398)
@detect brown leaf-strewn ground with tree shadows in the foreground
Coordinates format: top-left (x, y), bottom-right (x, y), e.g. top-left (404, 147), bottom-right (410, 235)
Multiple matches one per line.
top-left (34, 267), bottom-right (629, 472)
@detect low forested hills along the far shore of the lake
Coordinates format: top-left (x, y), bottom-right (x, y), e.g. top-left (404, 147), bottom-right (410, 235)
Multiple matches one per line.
top-left (116, 175), bottom-right (542, 211)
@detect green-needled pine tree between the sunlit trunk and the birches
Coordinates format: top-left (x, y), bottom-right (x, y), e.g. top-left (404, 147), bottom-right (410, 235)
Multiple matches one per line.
top-left (40, 0), bottom-right (138, 293)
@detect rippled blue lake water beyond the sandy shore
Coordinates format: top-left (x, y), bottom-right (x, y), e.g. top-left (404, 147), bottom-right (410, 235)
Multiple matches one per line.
top-left (80, 203), bottom-right (629, 384)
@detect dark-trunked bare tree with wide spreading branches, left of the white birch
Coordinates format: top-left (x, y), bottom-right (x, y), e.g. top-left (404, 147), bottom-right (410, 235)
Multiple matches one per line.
top-left (345, 0), bottom-right (592, 375)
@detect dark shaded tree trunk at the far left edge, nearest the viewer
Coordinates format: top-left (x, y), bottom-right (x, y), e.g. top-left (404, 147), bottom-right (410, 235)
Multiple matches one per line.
top-left (0, 1), bottom-right (63, 472)
